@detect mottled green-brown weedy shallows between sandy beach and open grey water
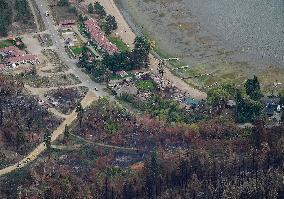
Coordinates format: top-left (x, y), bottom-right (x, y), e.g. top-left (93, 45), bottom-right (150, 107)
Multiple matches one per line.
top-left (115, 0), bottom-right (284, 93)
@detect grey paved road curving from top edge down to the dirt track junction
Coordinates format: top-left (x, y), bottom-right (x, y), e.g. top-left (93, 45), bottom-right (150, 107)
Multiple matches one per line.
top-left (35, 0), bottom-right (112, 98)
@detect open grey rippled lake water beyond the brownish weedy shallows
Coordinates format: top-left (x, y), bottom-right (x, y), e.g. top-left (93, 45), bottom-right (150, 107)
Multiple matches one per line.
top-left (182, 0), bottom-right (284, 67)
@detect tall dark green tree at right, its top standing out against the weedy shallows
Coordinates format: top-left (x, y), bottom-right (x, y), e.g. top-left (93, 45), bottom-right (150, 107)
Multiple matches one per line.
top-left (245, 76), bottom-right (262, 100)
